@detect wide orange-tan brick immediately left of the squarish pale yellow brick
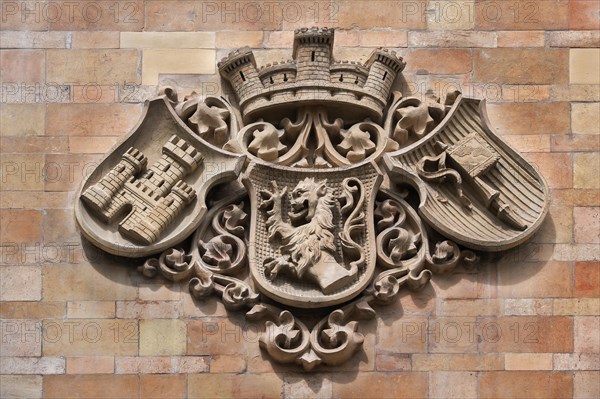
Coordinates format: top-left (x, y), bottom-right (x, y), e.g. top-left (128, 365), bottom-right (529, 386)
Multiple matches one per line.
top-left (43, 319), bottom-right (138, 357)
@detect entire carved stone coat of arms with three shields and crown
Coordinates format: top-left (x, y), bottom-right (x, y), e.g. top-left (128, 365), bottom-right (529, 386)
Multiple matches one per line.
top-left (75, 28), bottom-right (548, 370)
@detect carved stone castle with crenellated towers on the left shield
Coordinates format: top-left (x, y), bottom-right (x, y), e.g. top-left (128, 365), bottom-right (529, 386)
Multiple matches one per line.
top-left (81, 135), bottom-right (202, 245)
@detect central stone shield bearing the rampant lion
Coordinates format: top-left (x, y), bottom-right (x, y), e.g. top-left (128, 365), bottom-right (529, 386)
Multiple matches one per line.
top-left (244, 161), bottom-right (382, 308)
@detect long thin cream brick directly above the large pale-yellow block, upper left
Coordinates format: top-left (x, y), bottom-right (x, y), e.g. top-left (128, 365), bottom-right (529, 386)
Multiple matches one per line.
top-left (121, 32), bottom-right (215, 49)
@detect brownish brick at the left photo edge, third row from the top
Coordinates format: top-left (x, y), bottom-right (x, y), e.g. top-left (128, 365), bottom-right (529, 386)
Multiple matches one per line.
top-left (0, 50), bottom-right (44, 85)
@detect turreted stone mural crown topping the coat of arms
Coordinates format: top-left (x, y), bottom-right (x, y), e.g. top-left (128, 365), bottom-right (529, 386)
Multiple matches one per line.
top-left (218, 28), bottom-right (405, 122)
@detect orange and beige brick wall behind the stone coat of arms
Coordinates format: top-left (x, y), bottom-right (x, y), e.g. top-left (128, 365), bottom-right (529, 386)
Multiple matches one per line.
top-left (0, 0), bottom-right (600, 398)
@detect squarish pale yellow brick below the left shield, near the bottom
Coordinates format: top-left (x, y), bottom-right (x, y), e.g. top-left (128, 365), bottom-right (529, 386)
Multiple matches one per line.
top-left (140, 319), bottom-right (186, 356)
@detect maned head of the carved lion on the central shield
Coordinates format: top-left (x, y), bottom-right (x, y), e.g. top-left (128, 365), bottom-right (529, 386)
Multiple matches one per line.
top-left (289, 177), bottom-right (333, 222)
